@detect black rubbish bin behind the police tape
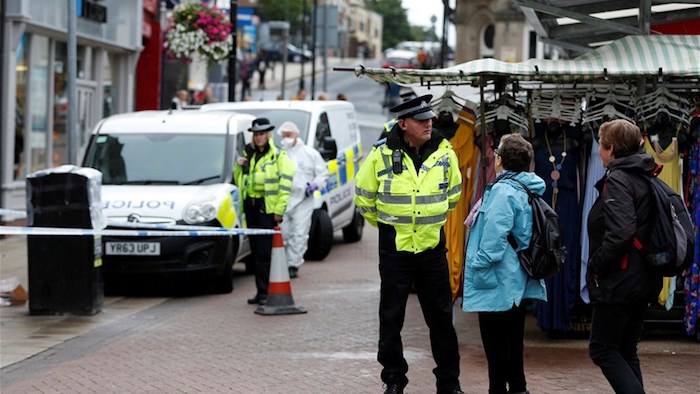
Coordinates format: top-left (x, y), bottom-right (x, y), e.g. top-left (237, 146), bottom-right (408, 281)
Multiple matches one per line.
top-left (27, 166), bottom-right (104, 315)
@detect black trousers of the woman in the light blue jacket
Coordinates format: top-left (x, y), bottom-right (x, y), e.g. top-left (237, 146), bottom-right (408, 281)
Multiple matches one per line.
top-left (479, 300), bottom-right (527, 394)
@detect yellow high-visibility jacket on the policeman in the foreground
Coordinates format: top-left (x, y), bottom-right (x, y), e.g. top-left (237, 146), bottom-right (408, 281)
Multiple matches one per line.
top-left (355, 135), bottom-right (462, 253)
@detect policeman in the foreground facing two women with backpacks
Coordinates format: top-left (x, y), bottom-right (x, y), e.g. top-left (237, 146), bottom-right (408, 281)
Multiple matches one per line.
top-left (355, 95), bottom-right (462, 394)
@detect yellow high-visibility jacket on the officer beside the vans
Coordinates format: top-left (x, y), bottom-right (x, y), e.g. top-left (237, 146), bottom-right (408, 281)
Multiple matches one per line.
top-left (233, 144), bottom-right (294, 216)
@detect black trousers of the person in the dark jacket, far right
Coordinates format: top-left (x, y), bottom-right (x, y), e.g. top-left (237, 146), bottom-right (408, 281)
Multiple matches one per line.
top-left (588, 302), bottom-right (647, 394)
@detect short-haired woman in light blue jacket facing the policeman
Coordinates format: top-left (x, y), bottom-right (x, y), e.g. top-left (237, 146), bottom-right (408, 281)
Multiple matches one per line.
top-left (463, 134), bottom-right (547, 394)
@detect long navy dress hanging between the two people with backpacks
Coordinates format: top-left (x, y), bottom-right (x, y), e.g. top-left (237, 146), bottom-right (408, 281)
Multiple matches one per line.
top-left (533, 122), bottom-right (582, 331)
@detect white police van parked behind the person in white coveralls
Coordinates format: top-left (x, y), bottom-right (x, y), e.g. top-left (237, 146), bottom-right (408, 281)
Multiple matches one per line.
top-left (200, 100), bottom-right (364, 260)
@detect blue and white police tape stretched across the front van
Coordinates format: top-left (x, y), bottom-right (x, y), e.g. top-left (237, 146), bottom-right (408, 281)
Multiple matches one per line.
top-left (0, 226), bottom-right (279, 237)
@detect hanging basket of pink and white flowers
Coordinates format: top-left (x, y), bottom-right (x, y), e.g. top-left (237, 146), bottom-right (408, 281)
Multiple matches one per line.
top-left (164, 3), bottom-right (233, 62)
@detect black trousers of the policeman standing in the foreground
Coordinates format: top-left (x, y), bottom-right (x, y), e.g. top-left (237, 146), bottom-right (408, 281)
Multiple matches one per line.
top-left (377, 251), bottom-right (459, 393)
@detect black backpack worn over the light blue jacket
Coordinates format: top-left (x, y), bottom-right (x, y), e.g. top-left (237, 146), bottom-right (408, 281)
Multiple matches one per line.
top-left (500, 178), bottom-right (566, 279)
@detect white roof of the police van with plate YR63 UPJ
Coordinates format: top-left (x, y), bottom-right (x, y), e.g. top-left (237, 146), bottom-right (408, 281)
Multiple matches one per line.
top-left (93, 110), bottom-right (255, 134)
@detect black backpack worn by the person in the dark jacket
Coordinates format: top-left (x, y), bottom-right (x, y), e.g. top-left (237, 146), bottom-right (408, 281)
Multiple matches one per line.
top-left (634, 166), bottom-right (695, 277)
